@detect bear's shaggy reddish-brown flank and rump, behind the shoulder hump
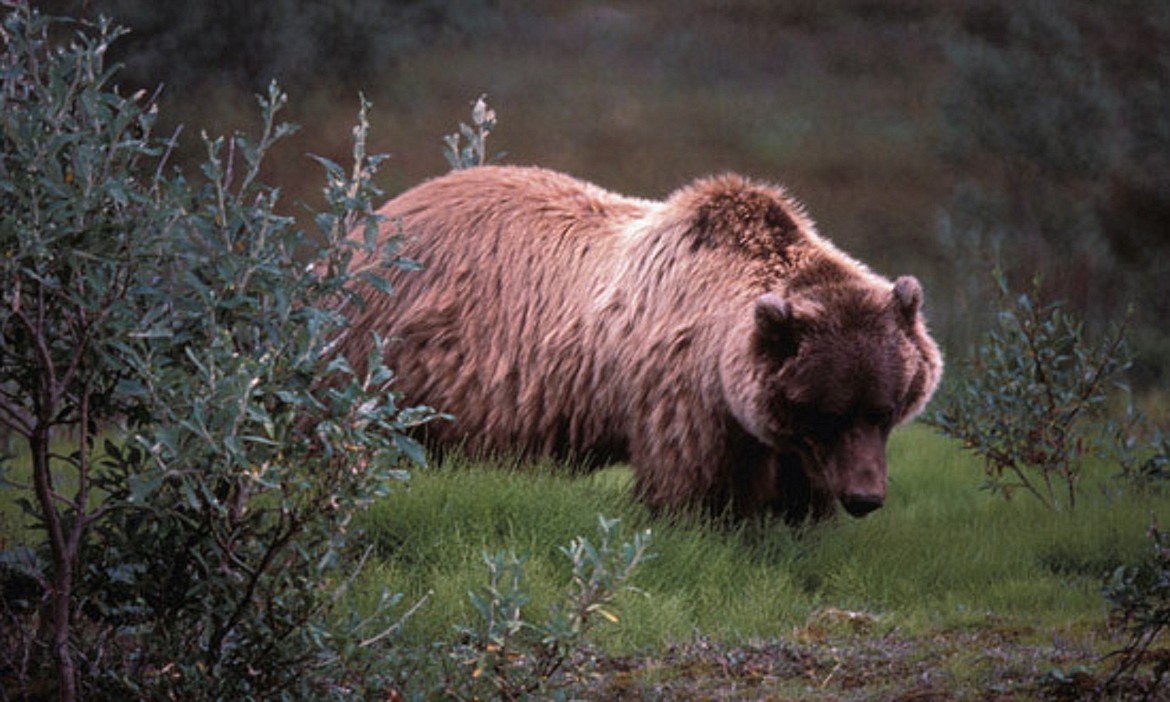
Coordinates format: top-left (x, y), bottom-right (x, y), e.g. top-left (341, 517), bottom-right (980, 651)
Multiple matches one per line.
top-left (347, 166), bottom-right (655, 459)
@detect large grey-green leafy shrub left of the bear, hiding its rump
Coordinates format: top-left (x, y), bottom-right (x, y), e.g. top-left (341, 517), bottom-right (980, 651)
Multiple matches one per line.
top-left (0, 2), bottom-right (432, 700)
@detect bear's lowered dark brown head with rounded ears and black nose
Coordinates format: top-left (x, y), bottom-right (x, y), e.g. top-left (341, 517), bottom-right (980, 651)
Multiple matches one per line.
top-left (721, 277), bottom-right (942, 516)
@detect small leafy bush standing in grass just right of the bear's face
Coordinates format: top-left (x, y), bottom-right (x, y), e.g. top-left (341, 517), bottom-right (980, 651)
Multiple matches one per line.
top-left (928, 270), bottom-right (1129, 510)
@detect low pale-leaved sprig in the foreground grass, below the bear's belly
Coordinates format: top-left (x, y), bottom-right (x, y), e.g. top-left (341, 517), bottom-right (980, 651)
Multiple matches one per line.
top-left (446, 516), bottom-right (653, 700)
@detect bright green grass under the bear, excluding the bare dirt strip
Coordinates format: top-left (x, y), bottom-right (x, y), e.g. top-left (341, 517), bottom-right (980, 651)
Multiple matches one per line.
top-left (362, 418), bottom-right (1170, 654)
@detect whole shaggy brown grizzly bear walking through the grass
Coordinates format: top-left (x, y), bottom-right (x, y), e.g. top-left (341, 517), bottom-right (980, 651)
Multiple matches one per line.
top-left (340, 166), bottom-right (942, 522)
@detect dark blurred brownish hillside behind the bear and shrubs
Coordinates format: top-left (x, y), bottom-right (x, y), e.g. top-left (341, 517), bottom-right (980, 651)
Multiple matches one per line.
top-left (34, 0), bottom-right (1170, 395)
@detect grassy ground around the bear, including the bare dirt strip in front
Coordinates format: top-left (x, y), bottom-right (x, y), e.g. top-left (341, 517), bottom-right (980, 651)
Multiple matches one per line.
top-left (355, 426), bottom-right (1170, 700)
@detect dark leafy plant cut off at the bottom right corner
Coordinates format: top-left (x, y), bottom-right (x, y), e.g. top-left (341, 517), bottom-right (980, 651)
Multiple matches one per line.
top-left (1103, 522), bottom-right (1170, 700)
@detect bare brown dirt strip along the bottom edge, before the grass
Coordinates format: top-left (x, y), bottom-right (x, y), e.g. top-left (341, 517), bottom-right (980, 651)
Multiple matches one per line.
top-left (579, 629), bottom-right (1170, 702)
